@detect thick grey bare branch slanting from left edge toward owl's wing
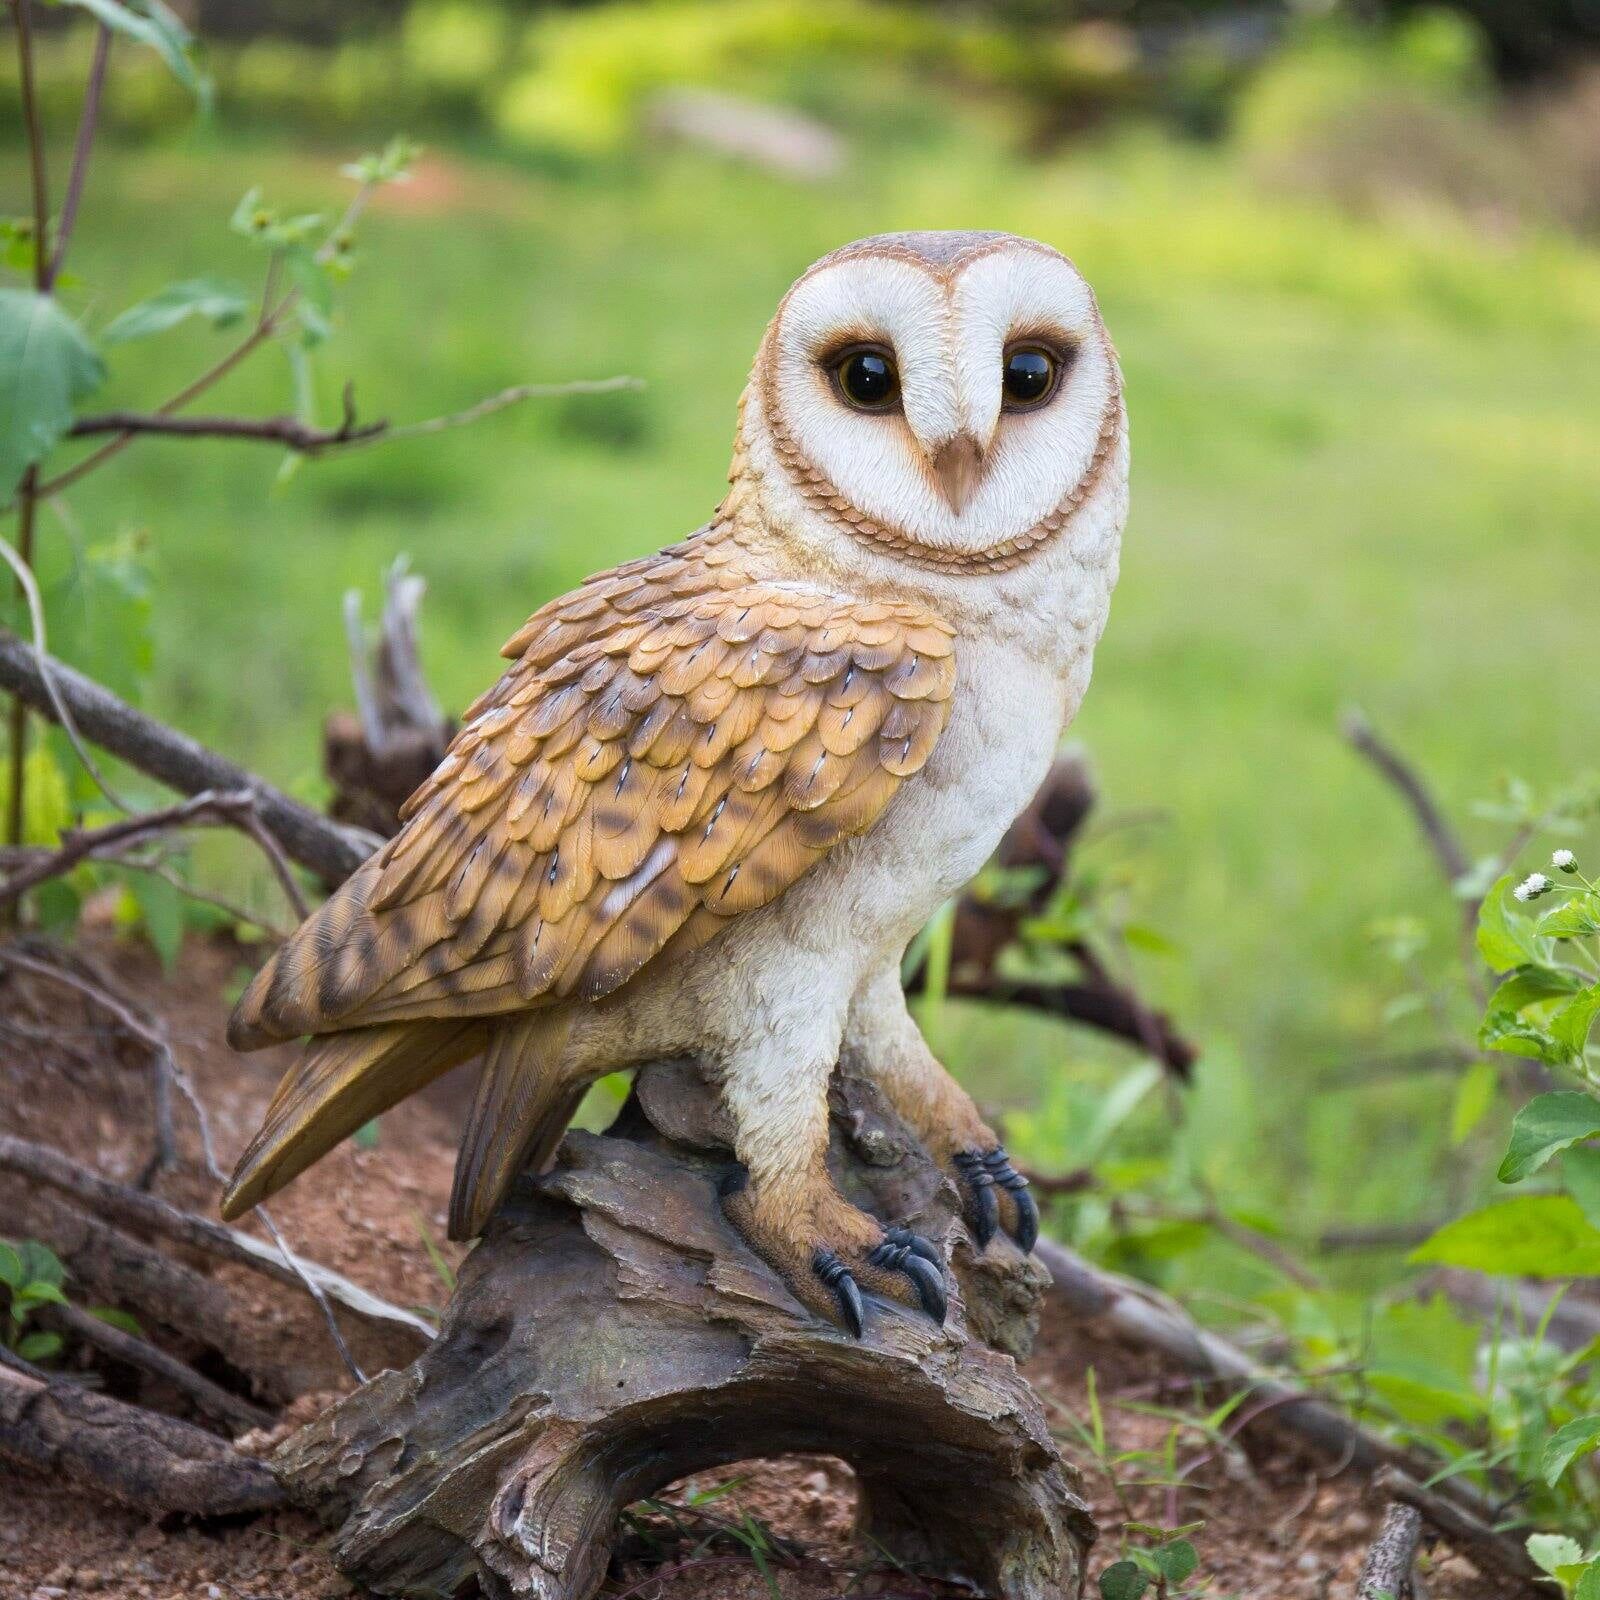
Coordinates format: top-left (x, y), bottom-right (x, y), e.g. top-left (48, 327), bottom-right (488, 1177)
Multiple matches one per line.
top-left (0, 630), bottom-right (378, 883)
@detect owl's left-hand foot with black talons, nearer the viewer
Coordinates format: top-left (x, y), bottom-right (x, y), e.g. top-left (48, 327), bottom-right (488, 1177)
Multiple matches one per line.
top-left (722, 1179), bottom-right (949, 1339)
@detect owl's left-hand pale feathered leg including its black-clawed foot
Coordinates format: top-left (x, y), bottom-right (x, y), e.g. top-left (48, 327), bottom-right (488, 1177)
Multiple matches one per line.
top-left (722, 1034), bottom-right (946, 1338)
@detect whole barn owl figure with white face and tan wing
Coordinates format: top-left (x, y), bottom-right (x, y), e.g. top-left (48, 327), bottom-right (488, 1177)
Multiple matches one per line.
top-left (222, 232), bottom-right (1128, 1336)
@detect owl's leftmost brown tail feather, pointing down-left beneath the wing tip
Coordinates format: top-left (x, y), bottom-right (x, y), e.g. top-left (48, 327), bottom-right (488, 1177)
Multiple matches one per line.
top-left (222, 1019), bottom-right (485, 1221)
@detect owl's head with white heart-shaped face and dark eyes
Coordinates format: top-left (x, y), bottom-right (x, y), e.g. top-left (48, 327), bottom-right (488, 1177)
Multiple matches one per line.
top-left (741, 232), bottom-right (1126, 573)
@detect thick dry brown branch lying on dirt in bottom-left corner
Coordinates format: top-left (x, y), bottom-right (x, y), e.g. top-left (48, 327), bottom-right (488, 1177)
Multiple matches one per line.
top-left (0, 1349), bottom-right (285, 1517)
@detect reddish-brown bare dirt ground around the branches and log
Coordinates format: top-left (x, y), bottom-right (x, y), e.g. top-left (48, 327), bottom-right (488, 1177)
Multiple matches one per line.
top-left (0, 944), bottom-right (1496, 1600)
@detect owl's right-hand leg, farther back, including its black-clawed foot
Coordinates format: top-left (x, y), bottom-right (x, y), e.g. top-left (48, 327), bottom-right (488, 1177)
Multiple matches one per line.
top-left (845, 965), bottom-right (1038, 1251)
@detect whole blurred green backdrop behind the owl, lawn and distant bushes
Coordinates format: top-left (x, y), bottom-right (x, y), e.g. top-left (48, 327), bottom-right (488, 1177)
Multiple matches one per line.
top-left (0, 0), bottom-right (1600, 1285)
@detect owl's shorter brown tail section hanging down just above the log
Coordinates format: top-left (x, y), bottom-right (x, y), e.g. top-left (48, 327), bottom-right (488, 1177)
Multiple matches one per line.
top-left (450, 1006), bottom-right (586, 1238)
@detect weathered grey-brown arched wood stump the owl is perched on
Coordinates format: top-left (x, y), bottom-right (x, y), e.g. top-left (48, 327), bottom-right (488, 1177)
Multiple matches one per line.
top-left (270, 1062), bottom-right (1094, 1600)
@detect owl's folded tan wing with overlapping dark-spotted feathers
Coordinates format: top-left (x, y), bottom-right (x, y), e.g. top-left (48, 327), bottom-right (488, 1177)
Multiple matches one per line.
top-left (232, 542), bottom-right (955, 1048)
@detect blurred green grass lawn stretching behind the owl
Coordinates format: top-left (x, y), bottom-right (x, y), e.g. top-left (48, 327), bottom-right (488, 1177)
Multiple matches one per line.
top-left (12, 116), bottom-right (1600, 1248)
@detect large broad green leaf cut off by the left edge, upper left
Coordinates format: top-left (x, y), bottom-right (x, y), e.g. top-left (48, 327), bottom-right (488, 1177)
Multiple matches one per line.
top-left (0, 290), bottom-right (106, 493)
